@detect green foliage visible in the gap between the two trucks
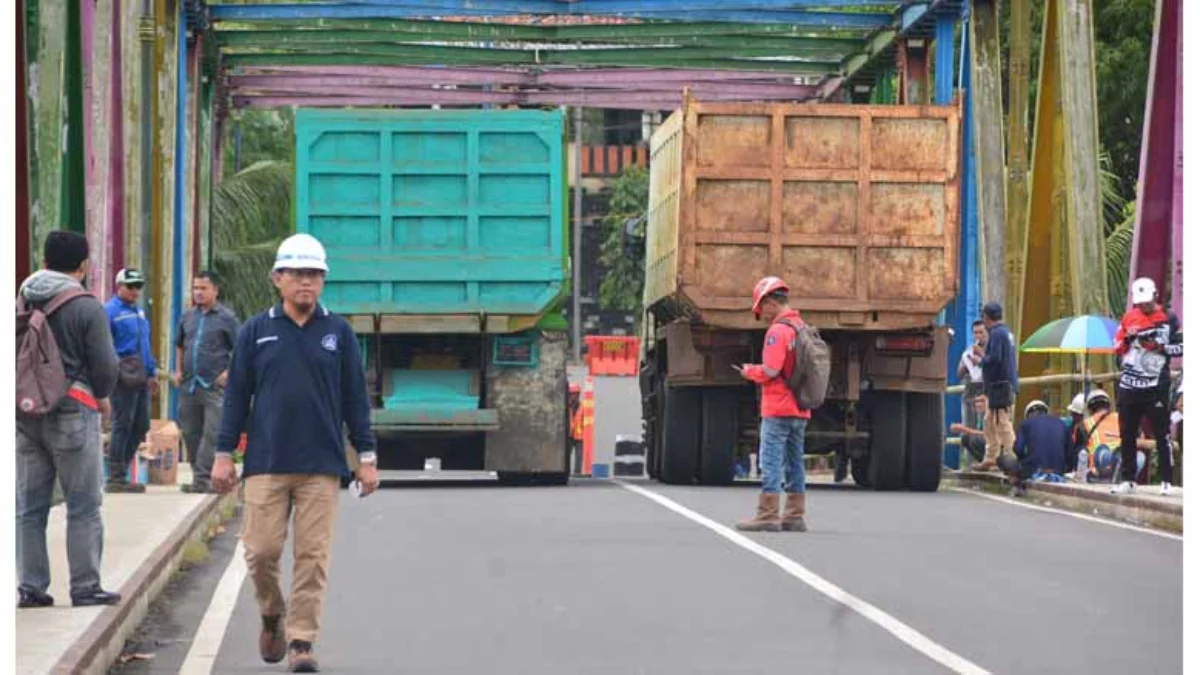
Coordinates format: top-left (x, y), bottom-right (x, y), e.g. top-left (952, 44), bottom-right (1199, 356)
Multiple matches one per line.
top-left (600, 166), bottom-right (650, 315)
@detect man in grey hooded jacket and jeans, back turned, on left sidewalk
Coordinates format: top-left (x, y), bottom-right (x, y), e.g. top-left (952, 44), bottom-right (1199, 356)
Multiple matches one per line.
top-left (17, 232), bottom-right (121, 608)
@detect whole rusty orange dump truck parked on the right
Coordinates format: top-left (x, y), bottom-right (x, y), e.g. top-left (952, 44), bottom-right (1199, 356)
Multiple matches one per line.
top-left (641, 101), bottom-right (961, 491)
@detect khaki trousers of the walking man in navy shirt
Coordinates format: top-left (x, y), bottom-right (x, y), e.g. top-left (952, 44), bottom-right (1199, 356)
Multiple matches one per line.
top-left (241, 473), bottom-right (341, 643)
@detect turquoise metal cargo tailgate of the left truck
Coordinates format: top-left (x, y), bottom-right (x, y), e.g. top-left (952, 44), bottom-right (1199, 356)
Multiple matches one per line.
top-left (295, 109), bottom-right (568, 315)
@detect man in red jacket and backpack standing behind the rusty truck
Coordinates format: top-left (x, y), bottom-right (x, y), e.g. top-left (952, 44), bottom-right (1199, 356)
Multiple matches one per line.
top-left (738, 276), bottom-right (829, 532)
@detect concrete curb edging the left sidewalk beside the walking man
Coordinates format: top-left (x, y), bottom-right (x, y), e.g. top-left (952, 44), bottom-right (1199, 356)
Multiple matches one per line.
top-left (50, 490), bottom-right (240, 675)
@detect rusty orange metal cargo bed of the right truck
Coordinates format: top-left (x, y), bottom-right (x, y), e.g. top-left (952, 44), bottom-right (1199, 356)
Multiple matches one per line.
top-left (646, 101), bottom-right (960, 328)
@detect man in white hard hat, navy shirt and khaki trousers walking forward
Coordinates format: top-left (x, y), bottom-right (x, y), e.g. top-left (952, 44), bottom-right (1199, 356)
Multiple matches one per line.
top-left (212, 234), bottom-right (379, 673)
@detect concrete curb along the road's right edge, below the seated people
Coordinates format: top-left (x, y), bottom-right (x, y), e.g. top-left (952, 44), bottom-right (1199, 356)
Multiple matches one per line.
top-left (942, 473), bottom-right (1183, 534)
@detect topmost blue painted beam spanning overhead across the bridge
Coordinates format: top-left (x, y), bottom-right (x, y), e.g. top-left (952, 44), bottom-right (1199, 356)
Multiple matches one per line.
top-left (210, 0), bottom-right (892, 30)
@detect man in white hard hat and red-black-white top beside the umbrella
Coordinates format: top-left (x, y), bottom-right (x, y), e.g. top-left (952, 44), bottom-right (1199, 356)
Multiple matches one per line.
top-left (1112, 277), bottom-right (1183, 495)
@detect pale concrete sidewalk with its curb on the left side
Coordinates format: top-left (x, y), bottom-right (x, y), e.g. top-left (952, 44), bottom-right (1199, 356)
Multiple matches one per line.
top-left (17, 464), bottom-right (236, 675)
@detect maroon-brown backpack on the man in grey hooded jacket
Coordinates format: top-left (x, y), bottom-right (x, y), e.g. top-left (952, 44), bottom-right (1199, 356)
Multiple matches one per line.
top-left (17, 289), bottom-right (88, 417)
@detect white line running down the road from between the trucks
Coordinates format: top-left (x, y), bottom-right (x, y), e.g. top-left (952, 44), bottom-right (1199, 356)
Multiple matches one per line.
top-left (620, 482), bottom-right (989, 675)
